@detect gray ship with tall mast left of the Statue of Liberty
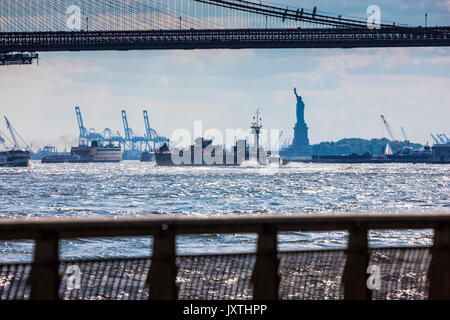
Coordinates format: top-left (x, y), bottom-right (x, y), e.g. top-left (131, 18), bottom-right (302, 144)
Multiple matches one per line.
top-left (155, 110), bottom-right (280, 166)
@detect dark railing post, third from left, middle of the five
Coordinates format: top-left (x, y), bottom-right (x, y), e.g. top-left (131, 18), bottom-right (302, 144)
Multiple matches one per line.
top-left (251, 226), bottom-right (280, 300)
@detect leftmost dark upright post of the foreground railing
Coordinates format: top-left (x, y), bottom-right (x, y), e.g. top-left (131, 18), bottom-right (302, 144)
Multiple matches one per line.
top-left (29, 231), bottom-right (60, 300)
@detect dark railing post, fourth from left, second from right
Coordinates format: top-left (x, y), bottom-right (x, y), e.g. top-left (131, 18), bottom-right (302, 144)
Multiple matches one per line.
top-left (342, 225), bottom-right (371, 300)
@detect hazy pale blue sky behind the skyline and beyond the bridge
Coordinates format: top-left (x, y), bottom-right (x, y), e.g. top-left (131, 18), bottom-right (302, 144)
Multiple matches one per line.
top-left (0, 0), bottom-right (450, 147)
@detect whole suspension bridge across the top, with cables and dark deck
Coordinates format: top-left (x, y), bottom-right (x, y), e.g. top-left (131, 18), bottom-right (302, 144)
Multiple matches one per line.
top-left (0, 0), bottom-right (450, 64)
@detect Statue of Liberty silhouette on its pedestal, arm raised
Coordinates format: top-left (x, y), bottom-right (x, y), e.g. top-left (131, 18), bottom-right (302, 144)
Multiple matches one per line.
top-left (280, 88), bottom-right (312, 161)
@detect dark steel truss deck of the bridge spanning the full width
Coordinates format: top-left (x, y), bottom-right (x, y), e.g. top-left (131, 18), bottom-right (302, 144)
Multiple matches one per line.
top-left (0, 27), bottom-right (450, 52)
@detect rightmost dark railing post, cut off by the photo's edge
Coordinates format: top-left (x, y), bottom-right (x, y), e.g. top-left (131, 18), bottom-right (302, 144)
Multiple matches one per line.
top-left (428, 223), bottom-right (450, 300)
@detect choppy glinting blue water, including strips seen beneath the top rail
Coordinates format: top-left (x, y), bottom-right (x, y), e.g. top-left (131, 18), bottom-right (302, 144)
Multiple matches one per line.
top-left (0, 161), bottom-right (450, 261)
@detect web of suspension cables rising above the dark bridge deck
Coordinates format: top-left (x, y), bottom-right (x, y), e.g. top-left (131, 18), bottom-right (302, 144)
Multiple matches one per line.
top-left (0, 0), bottom-right (408, 32)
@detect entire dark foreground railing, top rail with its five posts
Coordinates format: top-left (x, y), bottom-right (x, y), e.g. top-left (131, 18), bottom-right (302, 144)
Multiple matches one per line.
top-left (0, 212), bottom-right (450, 300)
